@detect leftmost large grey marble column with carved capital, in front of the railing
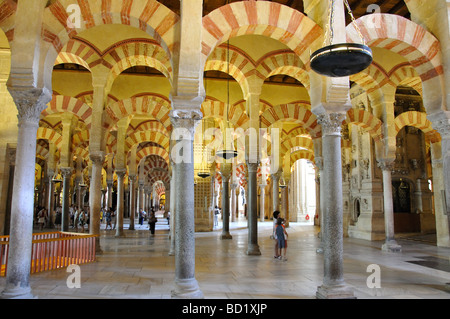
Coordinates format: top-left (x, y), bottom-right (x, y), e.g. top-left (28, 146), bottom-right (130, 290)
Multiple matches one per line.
top-left (1, 88), bottom-right (52, 299)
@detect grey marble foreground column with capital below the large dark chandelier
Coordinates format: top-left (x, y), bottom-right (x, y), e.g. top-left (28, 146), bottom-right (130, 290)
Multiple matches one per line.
top-left (316, 113), bottom-right (354, 299)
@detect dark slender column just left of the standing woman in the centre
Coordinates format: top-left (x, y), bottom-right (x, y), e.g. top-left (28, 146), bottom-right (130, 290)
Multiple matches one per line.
top-left (247, 162), bottom-right (261, 256)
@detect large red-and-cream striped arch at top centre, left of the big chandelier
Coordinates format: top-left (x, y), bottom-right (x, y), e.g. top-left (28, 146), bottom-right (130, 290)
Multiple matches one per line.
top-left (202, 1), bottom-right (322, 64)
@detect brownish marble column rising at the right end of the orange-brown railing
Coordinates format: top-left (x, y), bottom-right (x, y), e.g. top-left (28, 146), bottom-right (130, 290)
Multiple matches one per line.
top-left (89, 152), bottom-right (105, 254)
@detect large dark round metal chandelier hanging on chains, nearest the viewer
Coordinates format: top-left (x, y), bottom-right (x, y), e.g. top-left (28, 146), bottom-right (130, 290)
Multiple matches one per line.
top-left (310, 0), bottom-right (373, 77)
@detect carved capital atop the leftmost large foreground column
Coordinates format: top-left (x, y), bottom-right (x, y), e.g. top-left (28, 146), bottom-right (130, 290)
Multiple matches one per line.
top-left (8, 87), bottom-right (52, 125)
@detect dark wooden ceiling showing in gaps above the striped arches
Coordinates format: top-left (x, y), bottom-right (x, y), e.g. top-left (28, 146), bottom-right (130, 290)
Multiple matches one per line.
top-left (159, 0), bottom-right (410, 19)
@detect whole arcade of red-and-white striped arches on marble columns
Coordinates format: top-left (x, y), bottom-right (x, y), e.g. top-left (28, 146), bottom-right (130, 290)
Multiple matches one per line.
top-left (0, 0), bottom-right (450, 298)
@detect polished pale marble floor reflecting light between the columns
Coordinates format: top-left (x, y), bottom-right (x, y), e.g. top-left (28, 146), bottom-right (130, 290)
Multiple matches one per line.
top-left (0, 216), bottom-right (450, 299)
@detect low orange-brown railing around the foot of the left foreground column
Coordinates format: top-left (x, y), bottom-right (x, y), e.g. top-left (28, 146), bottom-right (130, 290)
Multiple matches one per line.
top-left (0, 232), bottom-right (97, 276)
